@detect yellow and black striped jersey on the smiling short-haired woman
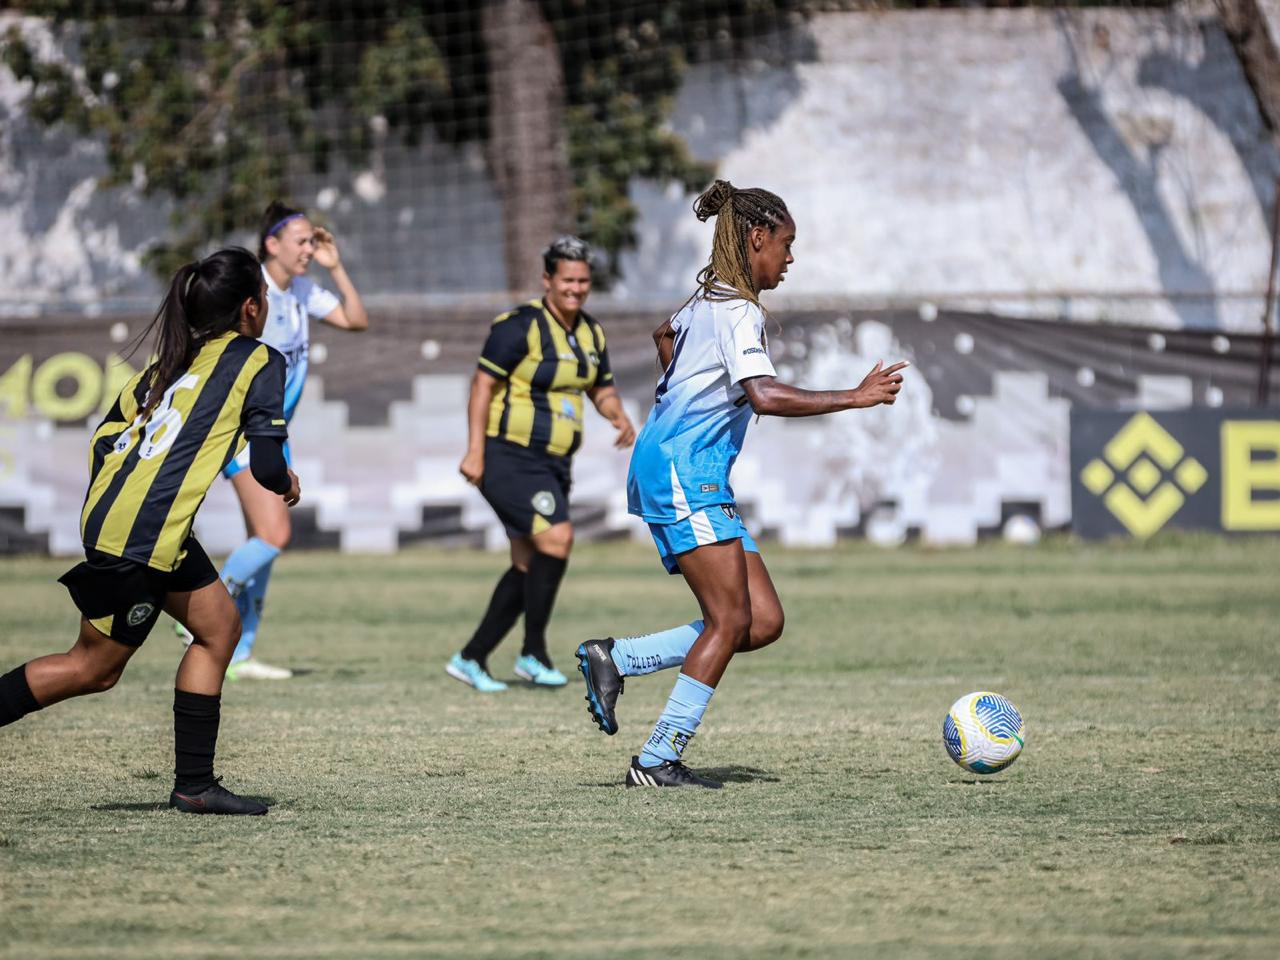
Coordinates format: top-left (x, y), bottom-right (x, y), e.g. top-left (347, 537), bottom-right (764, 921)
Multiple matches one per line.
top-left (480, 300), bottom-right (613, 457)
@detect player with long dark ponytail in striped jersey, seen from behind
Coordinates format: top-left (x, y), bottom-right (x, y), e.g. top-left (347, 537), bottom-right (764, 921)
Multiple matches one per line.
top-left (0, 247), bottom-right (300, 814)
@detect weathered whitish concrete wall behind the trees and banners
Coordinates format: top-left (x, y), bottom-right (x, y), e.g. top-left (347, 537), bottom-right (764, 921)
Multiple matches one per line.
top-left (0, 5), bottom-right (1280, 330)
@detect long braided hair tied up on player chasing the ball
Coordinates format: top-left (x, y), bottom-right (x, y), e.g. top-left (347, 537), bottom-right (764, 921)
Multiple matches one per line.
top-left (694, 180), bottom-right (791, 306)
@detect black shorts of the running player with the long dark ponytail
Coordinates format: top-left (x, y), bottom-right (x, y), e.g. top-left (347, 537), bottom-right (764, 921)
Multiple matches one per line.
top-left (58, 536), bottom-right (218, 646)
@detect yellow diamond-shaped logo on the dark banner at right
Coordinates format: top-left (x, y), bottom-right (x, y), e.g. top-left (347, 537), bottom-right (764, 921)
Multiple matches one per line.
top-left (1080, 413), bottom-right (1208, 540)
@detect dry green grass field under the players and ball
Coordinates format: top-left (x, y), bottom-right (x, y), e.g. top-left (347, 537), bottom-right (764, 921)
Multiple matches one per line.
top-left (0, 539), bottom-right (1280, 960)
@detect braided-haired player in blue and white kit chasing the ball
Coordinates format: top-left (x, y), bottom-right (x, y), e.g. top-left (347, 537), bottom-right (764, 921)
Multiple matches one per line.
top-left (577, 180), bottom-right (906, 788)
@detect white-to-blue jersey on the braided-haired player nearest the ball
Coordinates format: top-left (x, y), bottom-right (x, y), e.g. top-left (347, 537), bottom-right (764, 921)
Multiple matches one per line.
top-left (627, 296), bottom-right (776, 524)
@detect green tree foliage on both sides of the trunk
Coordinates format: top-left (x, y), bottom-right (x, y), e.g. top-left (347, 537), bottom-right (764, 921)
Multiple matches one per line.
top-left (0, 0), bottom-right (803, 279)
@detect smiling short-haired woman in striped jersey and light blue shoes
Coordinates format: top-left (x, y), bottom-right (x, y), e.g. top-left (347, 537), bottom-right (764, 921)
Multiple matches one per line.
top-left (445, 237), bottom-right (636, 694)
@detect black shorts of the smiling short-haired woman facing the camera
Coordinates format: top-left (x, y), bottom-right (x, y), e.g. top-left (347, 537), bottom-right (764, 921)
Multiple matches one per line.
top-left (480, 436), bottom-right (573, 538)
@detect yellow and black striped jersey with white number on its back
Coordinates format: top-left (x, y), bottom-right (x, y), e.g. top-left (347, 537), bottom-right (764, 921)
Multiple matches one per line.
top-left (81, 333), bottom-right (288, 571)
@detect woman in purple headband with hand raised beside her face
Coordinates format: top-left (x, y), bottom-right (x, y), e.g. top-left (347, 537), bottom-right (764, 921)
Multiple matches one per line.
top-left (184, 200), bottom-right (369, 680)
